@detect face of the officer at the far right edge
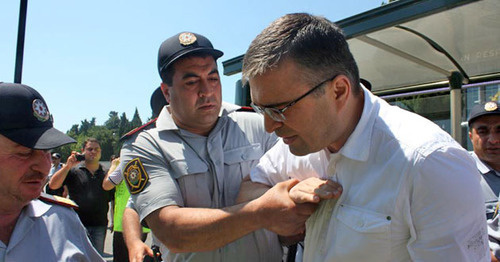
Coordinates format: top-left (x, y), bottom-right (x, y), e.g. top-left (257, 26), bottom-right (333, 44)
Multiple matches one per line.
top-left (469, 115), bottom-right (500, 169)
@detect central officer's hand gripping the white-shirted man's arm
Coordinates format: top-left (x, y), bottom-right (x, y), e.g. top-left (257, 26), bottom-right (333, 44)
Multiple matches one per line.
top-left (255, 179), bottom-right (317, 236)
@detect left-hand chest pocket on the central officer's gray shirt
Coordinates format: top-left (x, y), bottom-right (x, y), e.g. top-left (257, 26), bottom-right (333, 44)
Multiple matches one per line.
top-left (170, 158), bottom-right (210, 207)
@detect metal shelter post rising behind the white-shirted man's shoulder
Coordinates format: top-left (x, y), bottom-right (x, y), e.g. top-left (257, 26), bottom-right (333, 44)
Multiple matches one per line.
top-left (448, 71), bottom-right (463, 144)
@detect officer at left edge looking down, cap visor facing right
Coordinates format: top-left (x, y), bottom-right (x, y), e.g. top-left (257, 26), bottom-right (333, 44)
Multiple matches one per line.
top-left (0, 83), bottom-right (103, 261)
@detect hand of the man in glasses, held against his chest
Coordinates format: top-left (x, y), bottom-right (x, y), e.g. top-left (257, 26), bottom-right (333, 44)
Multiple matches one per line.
top-left (289, 177), bottom-right (342, 204)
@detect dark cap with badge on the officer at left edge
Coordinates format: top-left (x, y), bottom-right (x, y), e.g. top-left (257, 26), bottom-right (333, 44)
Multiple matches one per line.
top-left (0, 82), bottom-right (76, 149)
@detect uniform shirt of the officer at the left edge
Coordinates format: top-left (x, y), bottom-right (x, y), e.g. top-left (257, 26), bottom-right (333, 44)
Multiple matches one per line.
top-left (0, 200), bottom-right (104, 262)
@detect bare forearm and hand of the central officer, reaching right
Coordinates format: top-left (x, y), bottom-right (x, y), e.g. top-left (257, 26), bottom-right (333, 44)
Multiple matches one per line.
top-left (146, 180), bottom-right (316, 253)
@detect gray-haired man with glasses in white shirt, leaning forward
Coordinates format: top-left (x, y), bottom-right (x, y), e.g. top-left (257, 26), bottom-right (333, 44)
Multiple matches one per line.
top-left (242, 14), bottom-right (490, 261)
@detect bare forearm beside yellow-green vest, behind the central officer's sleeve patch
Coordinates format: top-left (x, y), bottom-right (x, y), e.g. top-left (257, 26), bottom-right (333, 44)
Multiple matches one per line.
top-left (122, 207), bottom-right (153, 262)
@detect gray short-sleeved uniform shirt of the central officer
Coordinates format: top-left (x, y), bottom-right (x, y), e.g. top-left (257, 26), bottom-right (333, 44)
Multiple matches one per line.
top-left (121, 103), bottom-right (282, 261)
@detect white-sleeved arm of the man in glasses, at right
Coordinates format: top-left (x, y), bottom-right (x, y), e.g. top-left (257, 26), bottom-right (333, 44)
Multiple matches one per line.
top-left (402, 147), bottom-right (491, 261)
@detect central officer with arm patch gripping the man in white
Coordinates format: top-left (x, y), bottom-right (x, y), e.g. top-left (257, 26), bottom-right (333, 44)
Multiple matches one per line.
top-left (121, 32), bottom-right (315, 261)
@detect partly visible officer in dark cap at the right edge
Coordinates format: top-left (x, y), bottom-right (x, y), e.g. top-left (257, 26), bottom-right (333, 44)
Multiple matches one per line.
top-left (468, 101), bottom-right (500, 261)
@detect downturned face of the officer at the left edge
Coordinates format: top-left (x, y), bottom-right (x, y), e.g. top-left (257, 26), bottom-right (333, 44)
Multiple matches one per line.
top-left (0, 135), bottom-right (50, 206)
